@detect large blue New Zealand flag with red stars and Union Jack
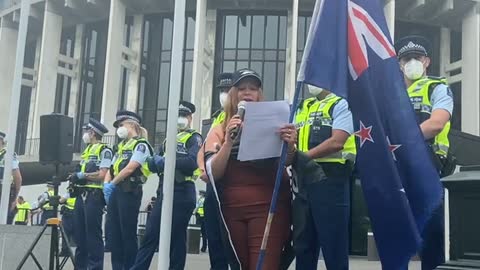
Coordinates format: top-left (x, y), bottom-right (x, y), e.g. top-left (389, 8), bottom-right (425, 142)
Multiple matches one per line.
top-left (298, 0), bottom-right (442, 270)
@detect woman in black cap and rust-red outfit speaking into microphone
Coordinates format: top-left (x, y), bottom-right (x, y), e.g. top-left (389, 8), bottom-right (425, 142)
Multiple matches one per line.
top-left (205, 69), bottom-right (297, 270)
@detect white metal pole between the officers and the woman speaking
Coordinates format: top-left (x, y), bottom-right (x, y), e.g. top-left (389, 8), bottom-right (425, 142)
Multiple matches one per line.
top-left (158, 0), bottom-right (185, 270)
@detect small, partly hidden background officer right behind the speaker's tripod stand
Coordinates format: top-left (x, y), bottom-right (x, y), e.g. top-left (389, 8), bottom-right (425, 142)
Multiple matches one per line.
top-left (59, 192), bottom-right (76, 256)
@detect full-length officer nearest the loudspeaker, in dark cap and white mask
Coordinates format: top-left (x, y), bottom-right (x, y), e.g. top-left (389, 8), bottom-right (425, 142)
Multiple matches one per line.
top-left (67, 118), bottom-right (113, 269)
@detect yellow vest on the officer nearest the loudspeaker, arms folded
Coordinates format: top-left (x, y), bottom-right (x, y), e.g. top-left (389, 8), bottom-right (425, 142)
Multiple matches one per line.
top-left (78, 143), bottom-right (107, 189)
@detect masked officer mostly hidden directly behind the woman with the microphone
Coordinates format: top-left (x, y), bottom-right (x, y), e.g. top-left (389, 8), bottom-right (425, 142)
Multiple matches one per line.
top-left (198, 73), bottom-right (233, 270)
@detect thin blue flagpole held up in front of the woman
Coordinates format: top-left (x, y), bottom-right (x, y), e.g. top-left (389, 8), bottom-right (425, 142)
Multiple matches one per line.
top-left (256, 81), bottom-right (303, 270)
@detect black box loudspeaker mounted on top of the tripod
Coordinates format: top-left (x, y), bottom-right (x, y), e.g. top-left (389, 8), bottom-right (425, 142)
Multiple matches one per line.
top-left (39, 114), bottom-right (73, 164)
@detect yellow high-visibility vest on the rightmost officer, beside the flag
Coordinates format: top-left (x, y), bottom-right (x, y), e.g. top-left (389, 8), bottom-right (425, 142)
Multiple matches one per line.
top-left (408, 77), bottom-right (450, 156)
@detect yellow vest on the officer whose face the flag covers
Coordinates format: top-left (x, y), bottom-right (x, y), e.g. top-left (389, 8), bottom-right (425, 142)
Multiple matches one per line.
top-left (295, 94), bottom-right (357, 164)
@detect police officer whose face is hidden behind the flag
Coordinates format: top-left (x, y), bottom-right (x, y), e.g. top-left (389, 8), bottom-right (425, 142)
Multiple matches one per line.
top-left (293, 86), bottom-right (356, 270)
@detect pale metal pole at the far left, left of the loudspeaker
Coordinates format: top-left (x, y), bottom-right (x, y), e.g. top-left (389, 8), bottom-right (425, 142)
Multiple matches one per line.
top-left (0, 0), bottom-right (31, 224)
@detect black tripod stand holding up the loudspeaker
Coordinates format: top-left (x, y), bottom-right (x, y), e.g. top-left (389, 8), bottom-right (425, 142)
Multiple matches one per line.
top-left (17, 163), bottom-right (75, 270)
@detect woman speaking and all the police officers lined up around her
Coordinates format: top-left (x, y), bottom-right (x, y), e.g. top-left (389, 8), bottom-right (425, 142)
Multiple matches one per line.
top-left (0, 36), bottom-right (453, 270)
